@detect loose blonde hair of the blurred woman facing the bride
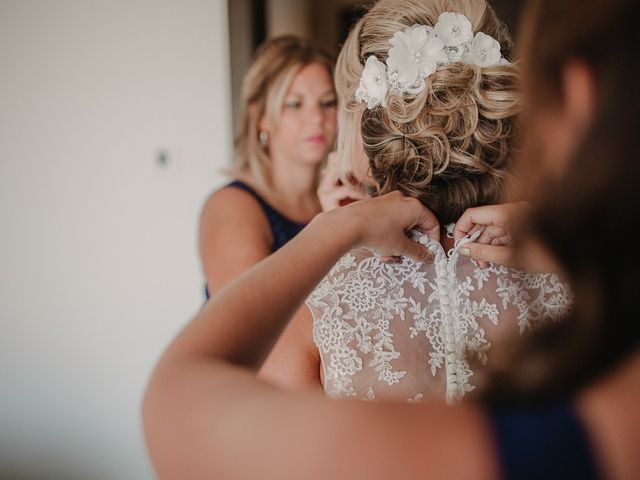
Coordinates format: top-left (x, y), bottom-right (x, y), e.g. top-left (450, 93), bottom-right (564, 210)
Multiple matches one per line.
top-left (234, 35), bottom-right (334, 190)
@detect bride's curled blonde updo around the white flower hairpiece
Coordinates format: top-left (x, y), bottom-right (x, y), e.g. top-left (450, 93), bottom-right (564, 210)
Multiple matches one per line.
top-left (336, 0), bottom-right (520, 223)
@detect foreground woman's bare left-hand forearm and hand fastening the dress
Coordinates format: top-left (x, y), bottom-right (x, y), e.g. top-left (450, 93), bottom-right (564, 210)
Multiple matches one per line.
top-left (165, 192), bottom-right (439, 369)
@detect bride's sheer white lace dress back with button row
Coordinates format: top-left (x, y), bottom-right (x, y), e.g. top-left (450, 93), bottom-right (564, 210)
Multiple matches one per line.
top-left (307, 234), bottom-right (571, 402)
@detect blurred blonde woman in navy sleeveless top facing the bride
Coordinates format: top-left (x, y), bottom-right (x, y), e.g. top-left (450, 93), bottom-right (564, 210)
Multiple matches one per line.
top-left (200, 36), bottom-right (350, 298)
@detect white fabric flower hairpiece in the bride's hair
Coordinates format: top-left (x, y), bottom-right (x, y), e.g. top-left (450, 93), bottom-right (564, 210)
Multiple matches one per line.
top-left (356, 12), bottom-right (509, 109)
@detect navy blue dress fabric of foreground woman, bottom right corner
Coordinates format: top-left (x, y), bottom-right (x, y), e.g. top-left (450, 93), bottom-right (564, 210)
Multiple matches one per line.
top-left (490, 403), bottom-right (602, 480)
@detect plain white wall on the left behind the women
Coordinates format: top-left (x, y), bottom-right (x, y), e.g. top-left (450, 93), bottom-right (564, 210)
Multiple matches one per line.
top-left (0, 0), bottom-right (232, 479)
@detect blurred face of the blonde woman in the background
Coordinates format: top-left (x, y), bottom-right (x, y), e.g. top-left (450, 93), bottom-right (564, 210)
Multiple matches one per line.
top-left (266, 63), bottom-right (336, 165)
